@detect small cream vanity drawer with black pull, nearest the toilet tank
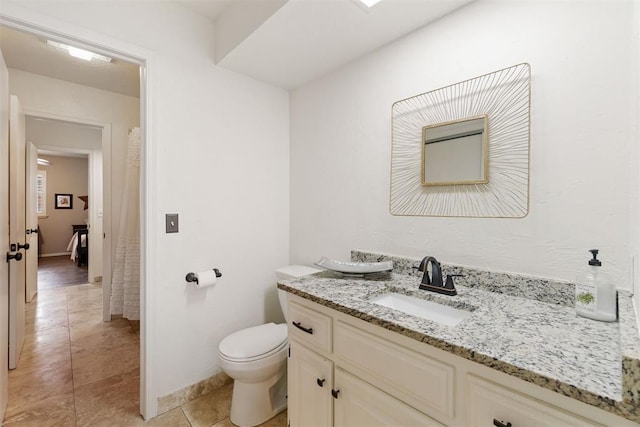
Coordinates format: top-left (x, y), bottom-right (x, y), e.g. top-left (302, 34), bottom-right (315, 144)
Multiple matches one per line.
top-left (289, 302), bottom-right (331, 353)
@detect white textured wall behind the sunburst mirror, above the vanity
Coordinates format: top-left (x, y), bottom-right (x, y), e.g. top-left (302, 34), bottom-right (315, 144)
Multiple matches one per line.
top-left (290, 1), bottom-right (638, 288)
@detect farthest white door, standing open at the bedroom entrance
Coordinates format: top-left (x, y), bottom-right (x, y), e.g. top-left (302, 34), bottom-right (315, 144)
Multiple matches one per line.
top-left (25, 142), bottom-right (38, 302)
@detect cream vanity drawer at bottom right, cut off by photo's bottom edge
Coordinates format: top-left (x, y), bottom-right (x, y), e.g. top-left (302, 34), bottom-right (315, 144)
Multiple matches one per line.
top-left (467, 375), bottom-right (600, 427)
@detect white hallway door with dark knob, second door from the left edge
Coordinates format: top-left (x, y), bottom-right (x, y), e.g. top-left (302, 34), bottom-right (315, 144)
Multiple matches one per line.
top-left (9, 95), bottom-right (27, 369)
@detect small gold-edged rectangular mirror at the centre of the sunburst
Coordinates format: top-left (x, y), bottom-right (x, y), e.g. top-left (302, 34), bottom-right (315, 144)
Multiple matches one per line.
top-left (422, 115), bottom-right (489, 186)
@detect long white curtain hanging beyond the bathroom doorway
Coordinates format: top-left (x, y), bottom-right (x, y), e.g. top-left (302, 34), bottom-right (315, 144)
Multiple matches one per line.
top-left (111, 127), bottom-right (140, 320)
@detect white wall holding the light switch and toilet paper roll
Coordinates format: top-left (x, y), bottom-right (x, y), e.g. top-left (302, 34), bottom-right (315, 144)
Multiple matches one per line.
top-left (3, 1), bottom-right (289, 415)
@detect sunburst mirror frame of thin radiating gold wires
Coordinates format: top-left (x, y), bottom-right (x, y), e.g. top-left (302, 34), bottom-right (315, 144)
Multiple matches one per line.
top-left (389, 64), bottom-right (531, 218)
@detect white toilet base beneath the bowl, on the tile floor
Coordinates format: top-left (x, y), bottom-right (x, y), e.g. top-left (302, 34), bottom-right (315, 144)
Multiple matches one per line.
top-left (230, 369), bottom-right (287, 427)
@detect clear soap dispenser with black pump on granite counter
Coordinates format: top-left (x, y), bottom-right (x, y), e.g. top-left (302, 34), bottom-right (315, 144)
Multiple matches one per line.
top-left (576, 249), bottom-right (618, 322)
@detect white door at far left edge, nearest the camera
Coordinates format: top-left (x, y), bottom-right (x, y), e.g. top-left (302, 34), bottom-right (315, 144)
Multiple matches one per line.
top-left (0, 47), bottom-right (15, 419)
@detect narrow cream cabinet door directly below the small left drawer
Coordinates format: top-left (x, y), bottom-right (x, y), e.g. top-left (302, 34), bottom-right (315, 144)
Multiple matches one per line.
top-left (287, 339), bottom-right (333, 427)
